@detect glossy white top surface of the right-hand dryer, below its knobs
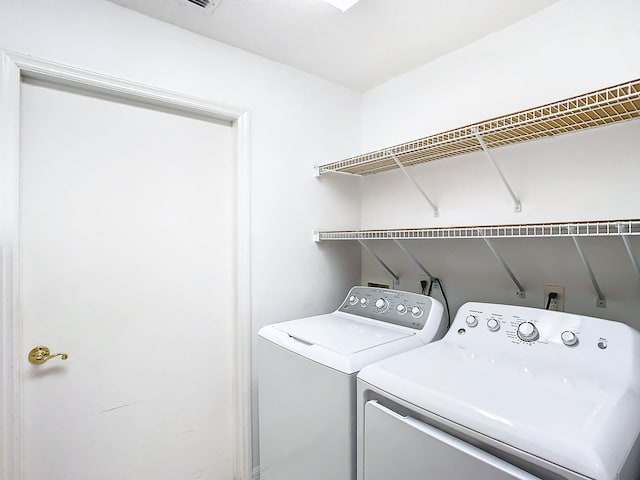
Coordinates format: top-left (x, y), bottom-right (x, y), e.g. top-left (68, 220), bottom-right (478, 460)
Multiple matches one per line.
top-left (358, 338), bottom-right (640, 479)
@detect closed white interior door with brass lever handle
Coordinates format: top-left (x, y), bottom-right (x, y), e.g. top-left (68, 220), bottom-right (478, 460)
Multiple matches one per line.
top-left (20, 81), bottom-right (235, 480)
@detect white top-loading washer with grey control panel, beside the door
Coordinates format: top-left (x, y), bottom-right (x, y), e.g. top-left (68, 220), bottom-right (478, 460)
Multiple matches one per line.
top-left (257, 287), bottom-right (447, 480)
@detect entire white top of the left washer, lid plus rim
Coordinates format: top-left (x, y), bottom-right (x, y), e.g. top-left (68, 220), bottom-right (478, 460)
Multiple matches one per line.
top-left (258, 312), bottom-right (424, 374)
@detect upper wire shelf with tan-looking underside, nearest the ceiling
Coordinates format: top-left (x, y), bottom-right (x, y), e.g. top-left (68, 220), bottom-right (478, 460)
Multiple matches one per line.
top-left (318, 79), bottom-right (640, 175)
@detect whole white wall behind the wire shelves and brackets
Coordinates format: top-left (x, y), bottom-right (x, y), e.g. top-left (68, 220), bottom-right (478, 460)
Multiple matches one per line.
top-left (362, 0), bottom-right (640, 328)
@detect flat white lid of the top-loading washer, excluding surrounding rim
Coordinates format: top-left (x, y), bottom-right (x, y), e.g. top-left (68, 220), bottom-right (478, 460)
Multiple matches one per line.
top-left (274, 314), bottom-right (415, 355)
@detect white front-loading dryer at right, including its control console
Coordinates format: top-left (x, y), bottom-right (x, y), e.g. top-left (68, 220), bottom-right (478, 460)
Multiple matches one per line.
top-left (357, 303), bottom-right (640, 480)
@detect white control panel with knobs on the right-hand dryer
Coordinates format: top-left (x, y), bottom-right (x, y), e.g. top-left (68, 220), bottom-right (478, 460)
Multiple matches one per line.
top-left (444, 302), bottom-right (640, 377)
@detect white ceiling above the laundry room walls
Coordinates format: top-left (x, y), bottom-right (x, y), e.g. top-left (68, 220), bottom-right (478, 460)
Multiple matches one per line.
top-left (110, 0), bottom-right (559, 91)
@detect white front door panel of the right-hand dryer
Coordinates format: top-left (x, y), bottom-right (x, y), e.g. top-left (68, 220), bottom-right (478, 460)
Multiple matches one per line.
top-left (364, 400), bottom-right (540, 480)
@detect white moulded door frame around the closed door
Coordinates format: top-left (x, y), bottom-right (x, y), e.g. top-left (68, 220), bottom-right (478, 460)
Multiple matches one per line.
top-left (0, 50), bottom-right (252, 480)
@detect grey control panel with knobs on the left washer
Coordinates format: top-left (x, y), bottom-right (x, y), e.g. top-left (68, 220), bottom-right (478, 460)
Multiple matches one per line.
top-left (338, 287), bottom-right (434, 330)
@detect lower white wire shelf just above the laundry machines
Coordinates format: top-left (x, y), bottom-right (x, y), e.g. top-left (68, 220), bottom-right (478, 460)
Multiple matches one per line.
top-left (316, 220), bottom-right (640, 241)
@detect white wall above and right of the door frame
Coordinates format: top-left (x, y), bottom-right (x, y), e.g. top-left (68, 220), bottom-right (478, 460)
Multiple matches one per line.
top-left (0, 0), bottom-right (360, 461)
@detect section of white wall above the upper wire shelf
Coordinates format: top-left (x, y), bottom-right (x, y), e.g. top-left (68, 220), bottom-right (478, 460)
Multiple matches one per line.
top-left (362, 0), bottom-right (640, 151)
